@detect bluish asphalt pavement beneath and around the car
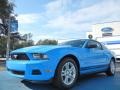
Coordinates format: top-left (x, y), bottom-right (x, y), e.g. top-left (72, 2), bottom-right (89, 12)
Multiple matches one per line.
top-left (0, 64), bottom-right (120, 90)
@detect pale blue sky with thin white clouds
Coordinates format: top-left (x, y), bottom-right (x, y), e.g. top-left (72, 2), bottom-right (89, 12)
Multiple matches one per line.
top-left (15, 0), bottom-right (120, 42)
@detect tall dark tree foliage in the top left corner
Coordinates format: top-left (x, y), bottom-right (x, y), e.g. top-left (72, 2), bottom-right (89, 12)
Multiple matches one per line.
top-left (0, 0), bottom-right (15, 34)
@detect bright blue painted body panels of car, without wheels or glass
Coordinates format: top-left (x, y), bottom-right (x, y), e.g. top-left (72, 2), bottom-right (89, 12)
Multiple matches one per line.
top-left (6, 39), bottom-right (114, 81)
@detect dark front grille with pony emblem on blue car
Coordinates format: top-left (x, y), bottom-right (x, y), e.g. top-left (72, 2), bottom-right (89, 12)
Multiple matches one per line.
top-left (11, 53), bottom-right (29, 60)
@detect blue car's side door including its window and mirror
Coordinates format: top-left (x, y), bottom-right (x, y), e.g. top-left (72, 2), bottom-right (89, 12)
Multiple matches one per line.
top-left (82, 40), bottom-right (106, 69)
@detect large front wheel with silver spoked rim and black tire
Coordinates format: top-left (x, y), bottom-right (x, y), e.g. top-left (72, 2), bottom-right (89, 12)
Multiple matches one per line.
top-left (53, 57), bottom-right (78, 89)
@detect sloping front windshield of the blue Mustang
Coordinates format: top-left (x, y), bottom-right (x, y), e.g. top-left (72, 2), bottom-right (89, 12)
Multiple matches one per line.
top-left (59, 40), bottom-right (85, 47)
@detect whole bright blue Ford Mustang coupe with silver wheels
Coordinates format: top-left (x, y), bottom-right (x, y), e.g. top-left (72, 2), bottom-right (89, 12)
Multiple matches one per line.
top-left (6, 39), bottom-right (115, 88)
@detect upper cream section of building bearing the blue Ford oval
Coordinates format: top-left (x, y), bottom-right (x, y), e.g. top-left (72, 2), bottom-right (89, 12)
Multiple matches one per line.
top-left (86, 21), bottom-right (120, 39)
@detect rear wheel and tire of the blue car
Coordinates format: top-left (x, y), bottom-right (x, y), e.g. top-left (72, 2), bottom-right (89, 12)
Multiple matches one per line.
top-left (106, 60), bottom-right (116, 76)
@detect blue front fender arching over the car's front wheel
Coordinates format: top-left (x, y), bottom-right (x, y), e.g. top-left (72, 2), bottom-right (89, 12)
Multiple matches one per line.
top-left (47, 48), bottom-right (80, 74)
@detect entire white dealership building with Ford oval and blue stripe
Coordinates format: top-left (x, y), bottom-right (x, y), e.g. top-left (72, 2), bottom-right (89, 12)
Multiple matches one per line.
top-left (86, 21), bottom-right (120, 60)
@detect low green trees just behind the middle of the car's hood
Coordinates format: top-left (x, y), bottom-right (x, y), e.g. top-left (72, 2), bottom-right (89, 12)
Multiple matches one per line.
top-left (36, 39), bottom-right (58, 45)
